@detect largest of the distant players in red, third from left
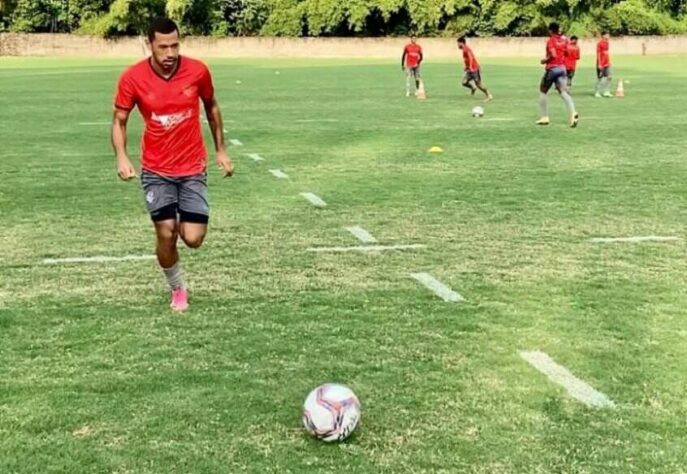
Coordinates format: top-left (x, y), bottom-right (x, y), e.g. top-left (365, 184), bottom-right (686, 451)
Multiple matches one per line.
top-left (537, 22), bottom-right (580, 128)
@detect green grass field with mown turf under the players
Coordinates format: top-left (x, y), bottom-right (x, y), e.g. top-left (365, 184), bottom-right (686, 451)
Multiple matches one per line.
top-left (0, 52), bottom-right (687, 474)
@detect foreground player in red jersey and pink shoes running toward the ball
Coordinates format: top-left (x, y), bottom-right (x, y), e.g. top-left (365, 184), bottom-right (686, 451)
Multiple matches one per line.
top-left (112, 18), bottom-right (234, 311)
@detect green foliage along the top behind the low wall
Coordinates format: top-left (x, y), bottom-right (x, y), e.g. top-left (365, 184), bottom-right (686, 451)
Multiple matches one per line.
top-left (0, 0), bottom-right (687, 36)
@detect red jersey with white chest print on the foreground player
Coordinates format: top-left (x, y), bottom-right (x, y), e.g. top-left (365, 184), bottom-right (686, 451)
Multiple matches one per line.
top-left (114, 56), bottom-right (214, 176)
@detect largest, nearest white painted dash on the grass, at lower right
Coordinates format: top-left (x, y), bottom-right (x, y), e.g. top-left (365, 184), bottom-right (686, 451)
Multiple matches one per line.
top-left (520, 351), bottom-right (615, 408)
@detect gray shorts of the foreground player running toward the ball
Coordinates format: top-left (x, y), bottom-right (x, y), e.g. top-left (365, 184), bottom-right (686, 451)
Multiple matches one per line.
top-left (141, 170), bottom-right (210, 224)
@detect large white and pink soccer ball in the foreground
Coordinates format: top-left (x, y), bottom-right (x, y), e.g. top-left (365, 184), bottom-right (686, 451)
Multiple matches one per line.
top-left (303, 383), bottom-right (360, 442)
